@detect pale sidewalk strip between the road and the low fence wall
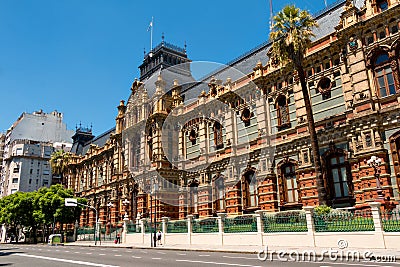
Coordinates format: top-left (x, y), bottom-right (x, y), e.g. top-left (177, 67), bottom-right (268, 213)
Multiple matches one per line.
top-left (65, 241), bottom-right (400, 261)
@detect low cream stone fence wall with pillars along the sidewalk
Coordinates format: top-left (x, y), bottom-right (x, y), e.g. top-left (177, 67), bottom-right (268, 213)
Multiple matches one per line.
top-left (122, 202), bottom-right (400, 249)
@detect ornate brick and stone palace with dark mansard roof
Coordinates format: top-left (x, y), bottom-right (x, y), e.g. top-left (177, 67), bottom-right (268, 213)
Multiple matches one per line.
top-left (66, 0), bottom-right (400, 228)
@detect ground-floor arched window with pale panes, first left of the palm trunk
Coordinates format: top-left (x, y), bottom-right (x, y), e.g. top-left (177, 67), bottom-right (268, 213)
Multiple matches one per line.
top-left (281, 163), bottom-right (299, 204)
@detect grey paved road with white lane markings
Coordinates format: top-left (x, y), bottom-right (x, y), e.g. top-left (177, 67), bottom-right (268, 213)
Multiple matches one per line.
top-left (0, 244), bottom-right (400, 267)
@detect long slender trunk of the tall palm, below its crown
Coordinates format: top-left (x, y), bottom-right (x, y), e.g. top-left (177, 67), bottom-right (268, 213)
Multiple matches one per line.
top-left (296, 64), bottom-right (326, 205)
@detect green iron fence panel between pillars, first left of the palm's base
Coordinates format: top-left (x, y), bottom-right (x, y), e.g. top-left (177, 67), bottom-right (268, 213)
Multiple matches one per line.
top-left (262, 211), bottom-right (307, 233)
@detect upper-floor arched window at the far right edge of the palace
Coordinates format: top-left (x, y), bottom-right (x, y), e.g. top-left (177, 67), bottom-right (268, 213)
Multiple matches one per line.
top-left (374, 52), bottom-right (396, 97)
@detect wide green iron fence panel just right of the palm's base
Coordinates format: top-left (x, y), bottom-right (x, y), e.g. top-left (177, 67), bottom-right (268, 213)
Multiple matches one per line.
top-left (313, 210), bottom-right (375, 232)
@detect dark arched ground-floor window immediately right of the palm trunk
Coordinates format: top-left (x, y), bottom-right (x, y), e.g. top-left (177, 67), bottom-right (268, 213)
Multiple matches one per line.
top-left (327, 154), bottom-right (350, 199)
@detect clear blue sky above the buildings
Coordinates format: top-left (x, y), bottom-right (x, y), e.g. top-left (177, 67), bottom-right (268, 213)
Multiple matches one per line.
top-left (0, 0), bottom-right (334, 135)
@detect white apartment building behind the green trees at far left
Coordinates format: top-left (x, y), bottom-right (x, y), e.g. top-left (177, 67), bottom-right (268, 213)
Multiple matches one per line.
top-left (0, 110), bottom-right (74, 197)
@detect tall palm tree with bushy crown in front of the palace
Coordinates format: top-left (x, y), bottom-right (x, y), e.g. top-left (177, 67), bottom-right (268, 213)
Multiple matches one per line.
top-left (269, 5), bottom-right (326, 205)
